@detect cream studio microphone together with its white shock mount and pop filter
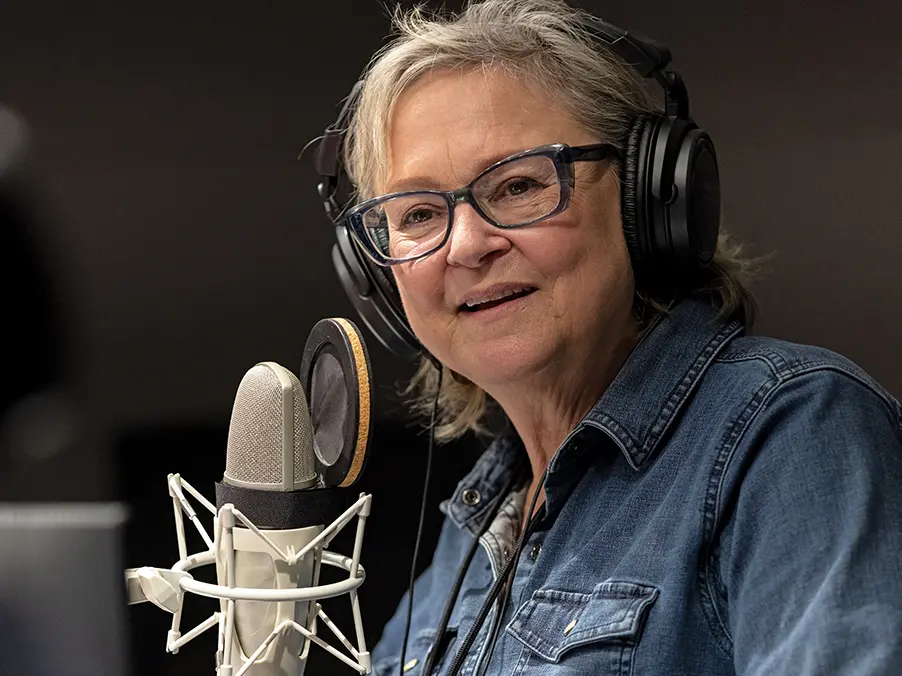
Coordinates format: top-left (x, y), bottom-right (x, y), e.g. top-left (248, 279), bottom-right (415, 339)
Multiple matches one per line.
top-left (126, 319), bottom-right (372, 676)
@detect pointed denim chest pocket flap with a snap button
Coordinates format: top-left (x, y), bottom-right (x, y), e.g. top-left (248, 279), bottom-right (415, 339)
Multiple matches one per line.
top-left (506, 581), bottom-right (658, 662)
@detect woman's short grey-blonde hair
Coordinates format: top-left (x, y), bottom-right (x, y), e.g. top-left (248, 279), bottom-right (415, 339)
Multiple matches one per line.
top-left (344, 0), bottom-right (755, 441)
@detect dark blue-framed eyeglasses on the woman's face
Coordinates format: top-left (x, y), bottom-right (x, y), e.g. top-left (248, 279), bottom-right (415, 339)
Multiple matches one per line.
top-left (345, 143), bottom-right (622, 267)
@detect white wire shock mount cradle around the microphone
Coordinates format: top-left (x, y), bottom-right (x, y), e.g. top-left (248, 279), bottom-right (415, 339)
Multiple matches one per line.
top-left (126, 474), bottom-right (373, 676)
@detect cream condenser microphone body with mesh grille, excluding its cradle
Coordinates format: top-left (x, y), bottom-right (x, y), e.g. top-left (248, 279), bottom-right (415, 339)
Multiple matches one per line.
top-left (216, 362), bottom-right (332, 676)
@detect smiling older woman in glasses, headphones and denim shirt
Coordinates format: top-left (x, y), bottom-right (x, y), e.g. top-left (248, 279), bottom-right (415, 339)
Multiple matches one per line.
top-left (316, 0), bottom-right (902, 676)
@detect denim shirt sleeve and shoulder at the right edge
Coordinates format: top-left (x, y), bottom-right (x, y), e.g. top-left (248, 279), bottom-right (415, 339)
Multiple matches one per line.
top-left (703, 346), bottom-right (902, 673)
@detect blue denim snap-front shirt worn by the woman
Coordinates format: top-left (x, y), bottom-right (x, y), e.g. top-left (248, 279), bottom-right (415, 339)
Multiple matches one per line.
top-left (373, 301), bottom-right (902, 676)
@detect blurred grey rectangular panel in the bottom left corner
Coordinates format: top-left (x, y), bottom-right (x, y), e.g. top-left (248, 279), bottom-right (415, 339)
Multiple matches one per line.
top-left (0, 503), bottom-right (128, 676)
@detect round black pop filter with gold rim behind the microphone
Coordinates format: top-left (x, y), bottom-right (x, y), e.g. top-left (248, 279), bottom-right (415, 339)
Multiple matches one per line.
top-left (300, 317), bottom-right (372, 487)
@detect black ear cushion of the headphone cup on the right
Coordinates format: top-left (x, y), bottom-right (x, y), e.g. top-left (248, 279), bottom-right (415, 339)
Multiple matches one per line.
top-left (620, 116), bottom-right (655, 277)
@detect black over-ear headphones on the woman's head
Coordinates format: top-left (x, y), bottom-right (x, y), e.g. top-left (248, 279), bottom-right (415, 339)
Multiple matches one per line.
top-left (316, 17), bottom-right (720, 357)
